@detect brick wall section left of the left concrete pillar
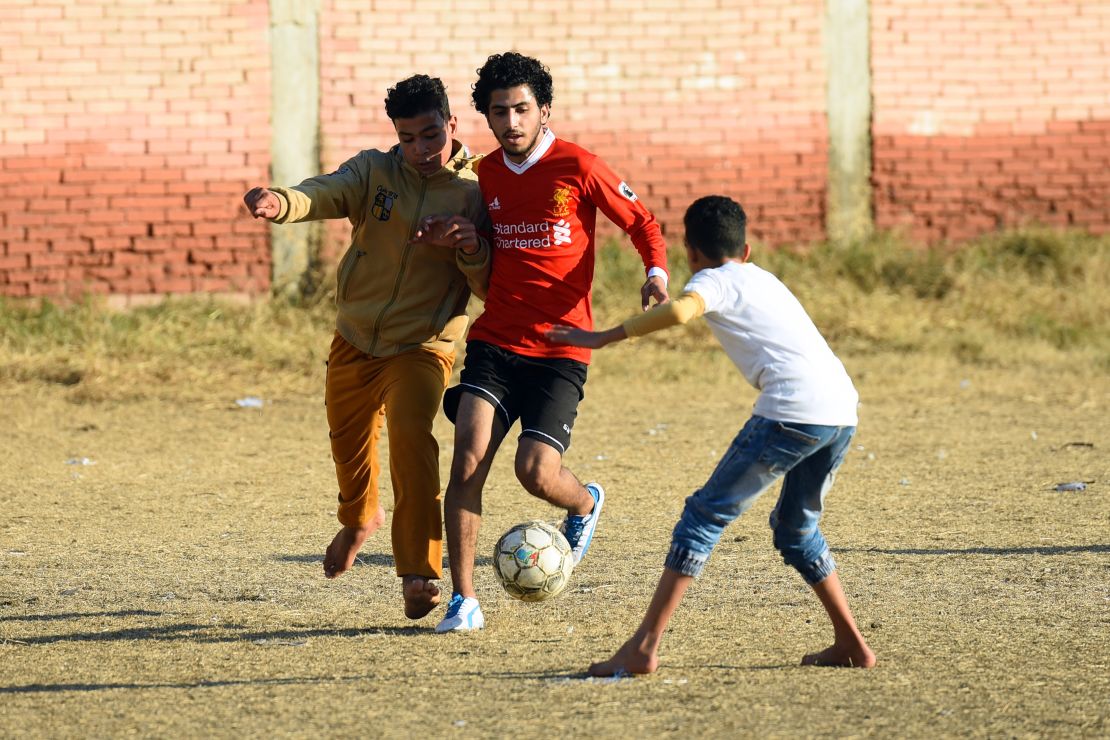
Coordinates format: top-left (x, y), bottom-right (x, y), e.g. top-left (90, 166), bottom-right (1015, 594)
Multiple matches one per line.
top-left (0, 0), bottom-right (270, 296)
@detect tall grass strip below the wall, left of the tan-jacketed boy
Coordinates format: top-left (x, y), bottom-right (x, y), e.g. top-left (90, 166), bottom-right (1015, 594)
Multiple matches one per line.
top-left (0, 297), bottom-right (333, 399)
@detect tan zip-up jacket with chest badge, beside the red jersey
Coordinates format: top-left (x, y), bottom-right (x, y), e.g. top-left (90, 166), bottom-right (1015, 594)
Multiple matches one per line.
top-left (270, 144), bottom-right (491, 357)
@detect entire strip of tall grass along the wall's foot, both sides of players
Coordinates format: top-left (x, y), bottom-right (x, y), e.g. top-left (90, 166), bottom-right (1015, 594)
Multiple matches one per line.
top-left (0, 230), bottom-right (1110, 401)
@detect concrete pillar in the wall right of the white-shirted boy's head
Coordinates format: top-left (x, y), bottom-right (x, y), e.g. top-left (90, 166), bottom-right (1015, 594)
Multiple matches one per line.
top-left (825, 0), bottom-right (875, 244)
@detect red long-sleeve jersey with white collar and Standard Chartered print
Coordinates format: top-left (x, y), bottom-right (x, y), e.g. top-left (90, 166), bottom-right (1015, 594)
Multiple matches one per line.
top-left (468, 131), bottom-right (667, 363)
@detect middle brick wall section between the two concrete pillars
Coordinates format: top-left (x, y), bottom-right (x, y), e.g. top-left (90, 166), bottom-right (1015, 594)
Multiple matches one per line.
top-left (321, 0), bottom-right (827, 262)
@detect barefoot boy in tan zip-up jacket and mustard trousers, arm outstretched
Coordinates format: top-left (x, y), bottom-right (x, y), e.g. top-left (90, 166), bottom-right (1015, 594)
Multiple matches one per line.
top-left (243, 74), bottom-right (491, 619)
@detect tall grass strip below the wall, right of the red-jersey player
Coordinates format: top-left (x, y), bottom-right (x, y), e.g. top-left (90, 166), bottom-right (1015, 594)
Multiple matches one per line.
top-left (595, 229), bottom-right (1110, 365)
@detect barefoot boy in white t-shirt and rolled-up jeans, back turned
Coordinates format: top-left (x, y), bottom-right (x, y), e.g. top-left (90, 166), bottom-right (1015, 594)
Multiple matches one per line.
top-left (547, 195), bottom-right (875, 676)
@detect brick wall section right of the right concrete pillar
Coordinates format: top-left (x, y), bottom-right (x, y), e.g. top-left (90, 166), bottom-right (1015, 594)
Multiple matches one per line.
top-left (871, 0), bottom-right (1110, 242)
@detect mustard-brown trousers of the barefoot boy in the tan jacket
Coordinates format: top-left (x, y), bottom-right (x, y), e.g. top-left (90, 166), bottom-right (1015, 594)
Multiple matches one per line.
top-left (324, 333), bottom-right (454, 578)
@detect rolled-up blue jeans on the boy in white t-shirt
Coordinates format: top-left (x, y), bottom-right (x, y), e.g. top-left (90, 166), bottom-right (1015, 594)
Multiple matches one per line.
top-left (666, 416), bottom-right (856, 586)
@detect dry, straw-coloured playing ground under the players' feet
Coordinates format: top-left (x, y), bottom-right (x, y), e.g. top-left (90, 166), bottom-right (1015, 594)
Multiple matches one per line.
top-left (0, 346), bottom-right (1110, 738)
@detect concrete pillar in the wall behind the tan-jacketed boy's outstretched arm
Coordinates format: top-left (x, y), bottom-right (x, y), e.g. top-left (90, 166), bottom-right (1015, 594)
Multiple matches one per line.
top-left (270, 0), bottom-right (323, 301)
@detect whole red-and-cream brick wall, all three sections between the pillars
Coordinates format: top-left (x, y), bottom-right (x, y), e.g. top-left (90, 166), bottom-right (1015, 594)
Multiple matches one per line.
top-left (0, 0), bottom-right (1110, 296)
